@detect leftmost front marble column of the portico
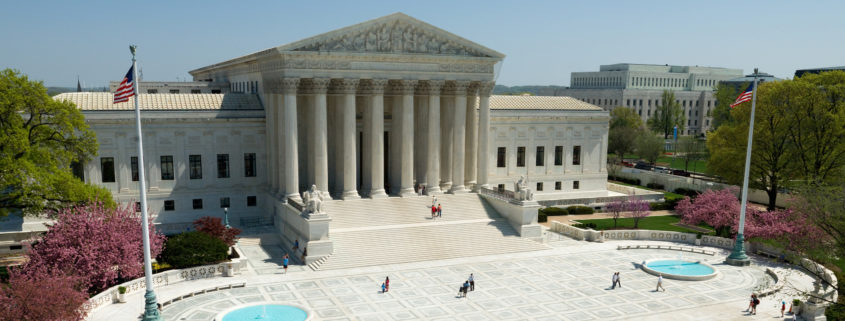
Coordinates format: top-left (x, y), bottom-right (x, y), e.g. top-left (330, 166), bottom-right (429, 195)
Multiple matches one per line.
top-left (279, 78), bottom-right (301, 200)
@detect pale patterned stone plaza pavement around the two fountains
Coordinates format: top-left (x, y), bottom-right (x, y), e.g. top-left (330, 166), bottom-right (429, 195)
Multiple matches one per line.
top-left (89, 233), bottom-right (811, 321)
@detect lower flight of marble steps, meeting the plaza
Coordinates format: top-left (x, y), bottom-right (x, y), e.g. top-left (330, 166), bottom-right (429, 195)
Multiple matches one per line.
top-left (311, 219), bottom-right (548, 270)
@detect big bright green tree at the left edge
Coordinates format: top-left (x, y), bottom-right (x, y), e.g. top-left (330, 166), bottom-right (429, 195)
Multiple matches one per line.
top-left (0, 69), bottom-right (114, 216)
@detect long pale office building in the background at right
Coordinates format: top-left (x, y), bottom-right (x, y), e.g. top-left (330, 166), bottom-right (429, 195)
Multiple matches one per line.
top-left (561, 63), bottom-right (742, 135)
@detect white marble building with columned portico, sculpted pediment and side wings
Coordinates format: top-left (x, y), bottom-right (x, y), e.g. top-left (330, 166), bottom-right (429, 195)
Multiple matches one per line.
top-left (51, 13), bottom-right (622, 260)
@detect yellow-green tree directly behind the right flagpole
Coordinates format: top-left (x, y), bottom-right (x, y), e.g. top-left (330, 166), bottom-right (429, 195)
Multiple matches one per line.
top-left (707, 81), bottom-right (800, 210)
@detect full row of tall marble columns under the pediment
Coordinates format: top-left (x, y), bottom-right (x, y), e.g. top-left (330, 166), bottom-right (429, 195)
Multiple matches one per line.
top-left (265, 78), bottom-right (493, 200)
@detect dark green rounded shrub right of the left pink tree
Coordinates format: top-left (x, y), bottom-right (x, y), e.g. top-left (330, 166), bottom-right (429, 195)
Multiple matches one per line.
top-left (161, 231), bottom-right (229, 269)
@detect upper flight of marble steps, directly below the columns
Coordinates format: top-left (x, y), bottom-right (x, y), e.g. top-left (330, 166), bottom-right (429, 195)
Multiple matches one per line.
top-left (323, 193), bottom-right (494, 229)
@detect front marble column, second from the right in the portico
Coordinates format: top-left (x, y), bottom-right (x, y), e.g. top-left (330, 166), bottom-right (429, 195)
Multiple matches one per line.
top-left (449, 81), bottom-right (469, 194)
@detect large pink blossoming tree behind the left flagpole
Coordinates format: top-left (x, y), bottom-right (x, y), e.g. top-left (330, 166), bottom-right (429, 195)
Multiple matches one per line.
top-left (22, 204), bottom-right (164, 293)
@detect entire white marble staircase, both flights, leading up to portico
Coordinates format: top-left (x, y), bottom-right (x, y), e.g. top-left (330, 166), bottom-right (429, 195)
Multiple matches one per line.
top-left (310, 193), bottom-right (548, 270)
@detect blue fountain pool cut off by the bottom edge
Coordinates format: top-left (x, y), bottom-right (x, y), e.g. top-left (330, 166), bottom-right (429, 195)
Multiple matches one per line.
top-left (214, 302), bottom-right (310, 321)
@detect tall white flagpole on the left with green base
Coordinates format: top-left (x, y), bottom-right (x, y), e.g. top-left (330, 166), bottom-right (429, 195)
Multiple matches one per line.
top-left (129, 45), bottom-right (162, 321)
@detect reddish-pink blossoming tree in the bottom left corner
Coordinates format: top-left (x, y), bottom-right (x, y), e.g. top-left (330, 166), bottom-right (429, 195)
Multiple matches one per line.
top-left (0, 268), bottom-right (88, 321)
